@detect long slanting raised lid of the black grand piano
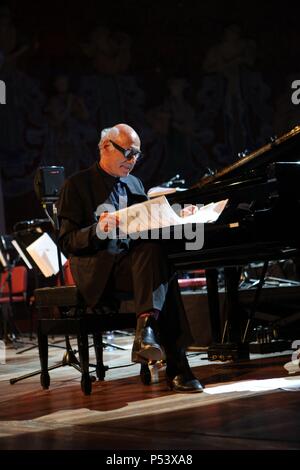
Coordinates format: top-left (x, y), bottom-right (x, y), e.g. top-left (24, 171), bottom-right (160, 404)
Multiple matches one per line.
top-left (191, 126), bottom-right (300, 189)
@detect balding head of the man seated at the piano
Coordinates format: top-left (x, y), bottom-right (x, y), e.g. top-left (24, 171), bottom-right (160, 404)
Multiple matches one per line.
top-left (99, 124), bottom-right (141, 176)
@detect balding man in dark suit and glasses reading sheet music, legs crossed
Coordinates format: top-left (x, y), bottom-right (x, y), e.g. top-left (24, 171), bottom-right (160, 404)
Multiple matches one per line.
top-left (58, 124), bottom-right (202, 392)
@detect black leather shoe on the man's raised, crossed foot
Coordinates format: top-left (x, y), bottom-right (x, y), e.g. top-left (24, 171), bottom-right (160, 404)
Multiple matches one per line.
top-left (131, 316), bottom-right (163, 363)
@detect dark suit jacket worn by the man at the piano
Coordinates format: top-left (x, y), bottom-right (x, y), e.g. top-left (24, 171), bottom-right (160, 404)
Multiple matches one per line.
top-left (57, 163), bottom-right (147, 306)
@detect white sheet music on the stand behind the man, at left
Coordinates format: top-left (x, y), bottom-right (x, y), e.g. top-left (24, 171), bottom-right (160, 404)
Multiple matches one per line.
top-left (26, 232), bottom-right (67, 277)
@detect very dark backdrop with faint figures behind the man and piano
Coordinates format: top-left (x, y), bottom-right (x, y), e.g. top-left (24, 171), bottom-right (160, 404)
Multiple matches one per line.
top-left (0, 0), bottom-right (300, 232)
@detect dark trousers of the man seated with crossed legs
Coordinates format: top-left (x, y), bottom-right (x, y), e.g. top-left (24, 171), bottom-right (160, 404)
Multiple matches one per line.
top-left (108, 240), bottom-right (192, 347)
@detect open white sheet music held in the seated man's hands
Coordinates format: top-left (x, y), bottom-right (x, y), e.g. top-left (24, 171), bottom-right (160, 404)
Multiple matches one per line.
top-left (115, 196), bottom-right (228, 235)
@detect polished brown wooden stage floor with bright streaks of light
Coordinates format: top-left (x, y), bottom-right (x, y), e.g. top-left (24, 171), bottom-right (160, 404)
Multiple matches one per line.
top-left (0, 336), bottom-right (300, 450)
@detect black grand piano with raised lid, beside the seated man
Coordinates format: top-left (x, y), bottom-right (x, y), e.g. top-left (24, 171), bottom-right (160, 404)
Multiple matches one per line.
top-left (168, 126), bottom-right (300, 360)
